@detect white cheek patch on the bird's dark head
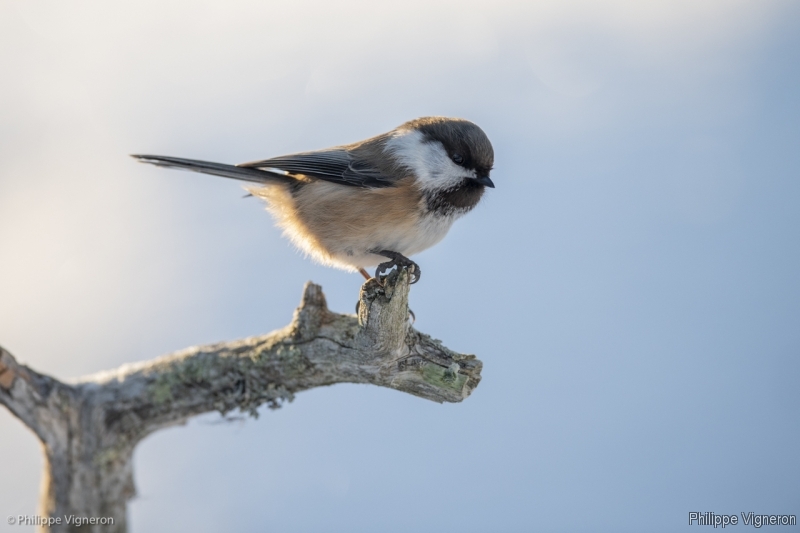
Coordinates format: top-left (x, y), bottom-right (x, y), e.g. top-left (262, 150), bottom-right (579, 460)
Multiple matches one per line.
top-left (386, 130), bottom-right (476, 190)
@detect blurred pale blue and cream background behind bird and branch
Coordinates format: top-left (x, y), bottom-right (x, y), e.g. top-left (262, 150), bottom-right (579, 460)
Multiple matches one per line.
top-left (0, 0), bottom-right (800, 533)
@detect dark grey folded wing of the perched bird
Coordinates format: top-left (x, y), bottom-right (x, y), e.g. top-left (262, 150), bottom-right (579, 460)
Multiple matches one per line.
top-left (236, 148), bottom-right (394, 188)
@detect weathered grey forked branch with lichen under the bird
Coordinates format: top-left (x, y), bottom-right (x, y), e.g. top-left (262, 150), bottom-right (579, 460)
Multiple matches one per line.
top-left (0, 270), bottom-right (482, 533)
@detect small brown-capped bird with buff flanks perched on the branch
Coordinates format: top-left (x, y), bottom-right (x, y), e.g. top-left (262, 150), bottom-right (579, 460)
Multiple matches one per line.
top-left (132, 117), bottom-right (494, 283)
